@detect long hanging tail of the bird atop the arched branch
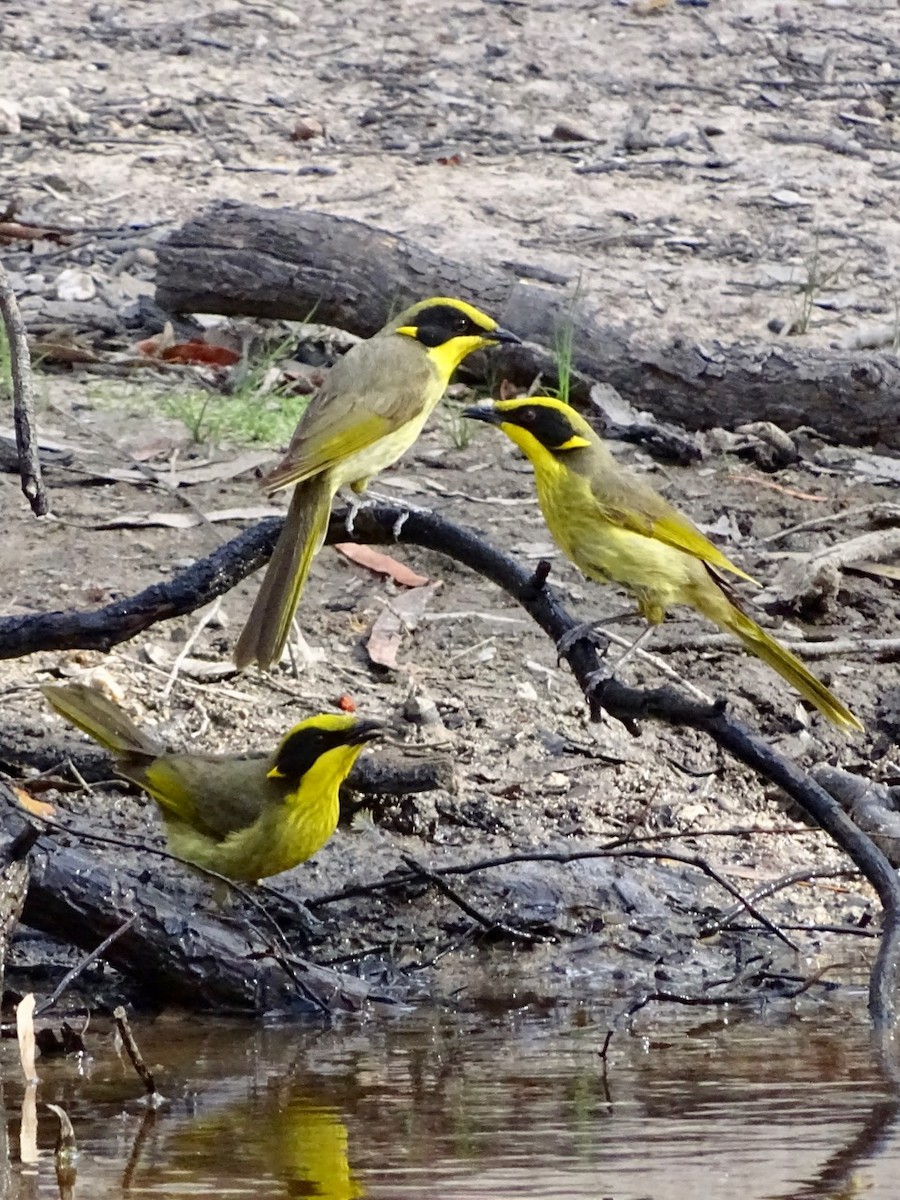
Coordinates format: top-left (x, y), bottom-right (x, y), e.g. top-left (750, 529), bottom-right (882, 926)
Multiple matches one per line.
top-left (234, 474), bottom-right (332, 668)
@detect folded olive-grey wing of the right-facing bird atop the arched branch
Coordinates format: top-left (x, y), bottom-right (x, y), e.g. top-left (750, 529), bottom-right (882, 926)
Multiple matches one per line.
top-left (263, 337), bottom-right (436, 491)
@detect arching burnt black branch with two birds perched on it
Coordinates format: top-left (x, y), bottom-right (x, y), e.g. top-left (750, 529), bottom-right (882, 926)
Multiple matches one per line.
top-left (0, 505), bottom-right (900, 1025)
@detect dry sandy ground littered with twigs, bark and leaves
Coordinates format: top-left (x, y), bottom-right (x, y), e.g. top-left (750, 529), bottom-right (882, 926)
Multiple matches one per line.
top-left (0, 0), bottom-right (900, 1000)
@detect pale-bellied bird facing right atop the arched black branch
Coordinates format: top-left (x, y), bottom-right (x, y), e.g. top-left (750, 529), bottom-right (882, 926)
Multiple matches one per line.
top-left (234, 296), bottom-right (518, 667)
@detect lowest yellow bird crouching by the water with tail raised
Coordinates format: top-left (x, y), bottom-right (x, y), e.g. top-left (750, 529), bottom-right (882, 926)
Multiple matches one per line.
top-left (42, 684), bottom-right (384, 883)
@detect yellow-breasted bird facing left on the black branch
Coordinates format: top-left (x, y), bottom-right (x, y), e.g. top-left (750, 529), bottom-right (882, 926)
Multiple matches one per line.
top-left (463, 396), bottom-right (863, 731)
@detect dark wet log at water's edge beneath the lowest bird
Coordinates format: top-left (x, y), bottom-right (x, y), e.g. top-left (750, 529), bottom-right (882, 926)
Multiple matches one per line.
top-left (2, 809), bottom-right (367, 1015)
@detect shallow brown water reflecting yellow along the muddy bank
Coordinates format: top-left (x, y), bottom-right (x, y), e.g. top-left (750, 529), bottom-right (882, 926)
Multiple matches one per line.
top-left (0, 1012), bottom-right (900, 1200)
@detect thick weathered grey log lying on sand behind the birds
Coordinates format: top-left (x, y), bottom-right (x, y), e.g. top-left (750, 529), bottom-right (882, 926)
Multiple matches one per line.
top-left (156, 203), bottom-right (900, 450)
